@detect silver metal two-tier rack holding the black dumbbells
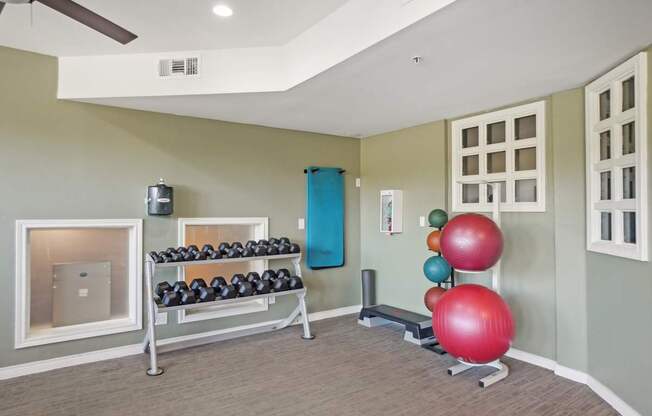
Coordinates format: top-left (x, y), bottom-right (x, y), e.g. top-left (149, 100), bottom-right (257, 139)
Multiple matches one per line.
top-left (143, 253), bottom-right (315, 376)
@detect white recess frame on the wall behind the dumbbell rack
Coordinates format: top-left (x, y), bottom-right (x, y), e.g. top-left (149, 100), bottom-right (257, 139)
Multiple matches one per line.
top-left (177, 217), bottom-right (269, 324)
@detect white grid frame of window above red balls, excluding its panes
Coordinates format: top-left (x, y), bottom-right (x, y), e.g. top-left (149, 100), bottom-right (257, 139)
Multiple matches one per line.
top-left (451, 101), bottom-right (546, 212)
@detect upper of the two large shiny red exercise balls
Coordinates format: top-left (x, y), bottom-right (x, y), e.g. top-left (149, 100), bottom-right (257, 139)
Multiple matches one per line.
top-left (439, 214), bottom-right (503, 271)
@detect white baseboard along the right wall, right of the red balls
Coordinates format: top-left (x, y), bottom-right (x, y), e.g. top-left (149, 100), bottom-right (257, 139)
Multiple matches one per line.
top-left (505, 348), bottom-right (641, 416)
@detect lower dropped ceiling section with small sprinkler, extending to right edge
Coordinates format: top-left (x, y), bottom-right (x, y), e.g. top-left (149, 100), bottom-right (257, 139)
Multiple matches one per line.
top-left (80, 0), bottom-right (652, 137)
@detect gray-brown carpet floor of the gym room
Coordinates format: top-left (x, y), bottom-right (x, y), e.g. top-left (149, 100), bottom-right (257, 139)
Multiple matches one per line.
top-left (0, 316), bottom-right (617, 416)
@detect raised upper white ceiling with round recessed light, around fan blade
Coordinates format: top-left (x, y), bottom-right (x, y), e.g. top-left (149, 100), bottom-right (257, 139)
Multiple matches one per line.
top-left (0, 0), bottom-right (347, 56)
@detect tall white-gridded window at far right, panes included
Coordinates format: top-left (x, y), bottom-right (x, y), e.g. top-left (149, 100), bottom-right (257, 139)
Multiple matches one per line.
top-left (585, 52), bottom-right (648, 261)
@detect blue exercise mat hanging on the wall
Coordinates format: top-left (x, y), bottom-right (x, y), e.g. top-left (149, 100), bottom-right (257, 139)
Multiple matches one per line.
top-left (304, 166), bottom-right (345, 269)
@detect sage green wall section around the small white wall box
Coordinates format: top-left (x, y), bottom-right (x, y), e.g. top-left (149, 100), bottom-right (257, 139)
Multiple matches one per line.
top-left (360, 121), bottom-right (447, 313)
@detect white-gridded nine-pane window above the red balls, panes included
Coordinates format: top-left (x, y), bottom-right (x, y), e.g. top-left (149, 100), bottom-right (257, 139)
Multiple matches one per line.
top-left (451, 101), bottom-right (546, 212)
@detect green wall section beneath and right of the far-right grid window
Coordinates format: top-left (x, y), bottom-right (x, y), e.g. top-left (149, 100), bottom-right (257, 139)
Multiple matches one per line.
top-left (587, 48), bottom-right (652, 415)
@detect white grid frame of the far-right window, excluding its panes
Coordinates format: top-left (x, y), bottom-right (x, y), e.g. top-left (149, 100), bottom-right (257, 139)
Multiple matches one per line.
top-left (585, 52), bottom-right (648, 261)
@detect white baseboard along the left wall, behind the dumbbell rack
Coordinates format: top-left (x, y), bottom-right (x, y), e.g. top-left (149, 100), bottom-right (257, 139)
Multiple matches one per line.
top-left (0, 305), bottom-right (362, 380)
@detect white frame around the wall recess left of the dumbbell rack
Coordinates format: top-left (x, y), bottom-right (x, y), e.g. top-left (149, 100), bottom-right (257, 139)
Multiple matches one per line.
top-left (14, 219), bottom-right (143, 349)
